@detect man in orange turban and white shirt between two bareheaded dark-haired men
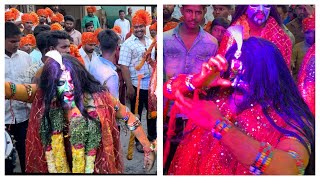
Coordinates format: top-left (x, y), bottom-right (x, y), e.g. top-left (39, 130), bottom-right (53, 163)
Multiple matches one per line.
top-left (79, 32), bottom-right (98, 71)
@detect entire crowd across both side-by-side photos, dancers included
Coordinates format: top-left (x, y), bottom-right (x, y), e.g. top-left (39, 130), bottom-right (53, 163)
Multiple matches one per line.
top-left (5, 5), bottom-right (316, 175)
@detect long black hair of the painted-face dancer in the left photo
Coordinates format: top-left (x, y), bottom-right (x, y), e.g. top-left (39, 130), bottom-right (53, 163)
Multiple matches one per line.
top-left (39, 55), bottom-right (107, 119)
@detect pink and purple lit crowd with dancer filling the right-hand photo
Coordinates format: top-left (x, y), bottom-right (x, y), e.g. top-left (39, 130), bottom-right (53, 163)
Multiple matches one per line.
top-left (163, 5), bottom-right (315, 175)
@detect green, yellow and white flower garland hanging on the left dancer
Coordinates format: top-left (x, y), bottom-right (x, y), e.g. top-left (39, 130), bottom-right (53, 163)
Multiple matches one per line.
top-left (40, 95), bottom-right (101, 173)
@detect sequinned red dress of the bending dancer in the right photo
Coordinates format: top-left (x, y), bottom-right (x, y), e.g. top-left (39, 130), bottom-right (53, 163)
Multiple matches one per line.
top-left (168, 92), bottom-right (285, 175)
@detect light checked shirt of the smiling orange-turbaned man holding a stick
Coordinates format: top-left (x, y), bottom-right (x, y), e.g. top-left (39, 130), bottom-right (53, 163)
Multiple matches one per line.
top-left (118, 35), bottom-right (154, 90)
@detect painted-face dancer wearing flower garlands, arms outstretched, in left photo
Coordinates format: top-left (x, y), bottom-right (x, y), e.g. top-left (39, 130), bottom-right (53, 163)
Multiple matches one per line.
top-left (5, 51), bottom-right (155, 174)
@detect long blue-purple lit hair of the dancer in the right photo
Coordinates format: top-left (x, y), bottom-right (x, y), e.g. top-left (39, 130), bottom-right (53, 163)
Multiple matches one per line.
top-left (224, 37), bottom-right (315, 174)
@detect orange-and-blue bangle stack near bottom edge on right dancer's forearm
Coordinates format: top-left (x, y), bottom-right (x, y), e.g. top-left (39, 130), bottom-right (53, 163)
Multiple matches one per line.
top-left (249, 142), bottom-right (273, 175)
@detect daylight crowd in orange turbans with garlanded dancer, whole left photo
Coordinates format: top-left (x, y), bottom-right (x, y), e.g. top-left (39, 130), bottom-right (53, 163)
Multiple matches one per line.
top-left (5, 5), bottom-right (157, 174)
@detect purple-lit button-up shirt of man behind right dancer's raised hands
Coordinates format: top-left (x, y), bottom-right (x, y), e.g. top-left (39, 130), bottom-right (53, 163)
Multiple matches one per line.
top-left (163, 23), bottom-right (218, 119)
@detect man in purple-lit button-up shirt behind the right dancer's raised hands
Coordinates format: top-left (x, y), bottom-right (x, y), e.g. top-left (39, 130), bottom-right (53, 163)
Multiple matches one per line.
top-left (163, 5), bottom-right (218, 172)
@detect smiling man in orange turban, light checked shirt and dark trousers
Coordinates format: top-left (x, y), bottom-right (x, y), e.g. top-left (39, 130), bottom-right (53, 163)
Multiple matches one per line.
top-left (118, 10), bottom-right (157, 152)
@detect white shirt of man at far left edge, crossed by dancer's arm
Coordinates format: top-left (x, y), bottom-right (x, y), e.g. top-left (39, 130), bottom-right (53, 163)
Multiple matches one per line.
top-left (5, 50), bottom-right (32, 124)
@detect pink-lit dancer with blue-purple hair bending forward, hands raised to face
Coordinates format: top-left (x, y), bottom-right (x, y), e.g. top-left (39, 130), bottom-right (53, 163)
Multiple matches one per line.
top-left (164, 37), bottom-right (315, 175)
